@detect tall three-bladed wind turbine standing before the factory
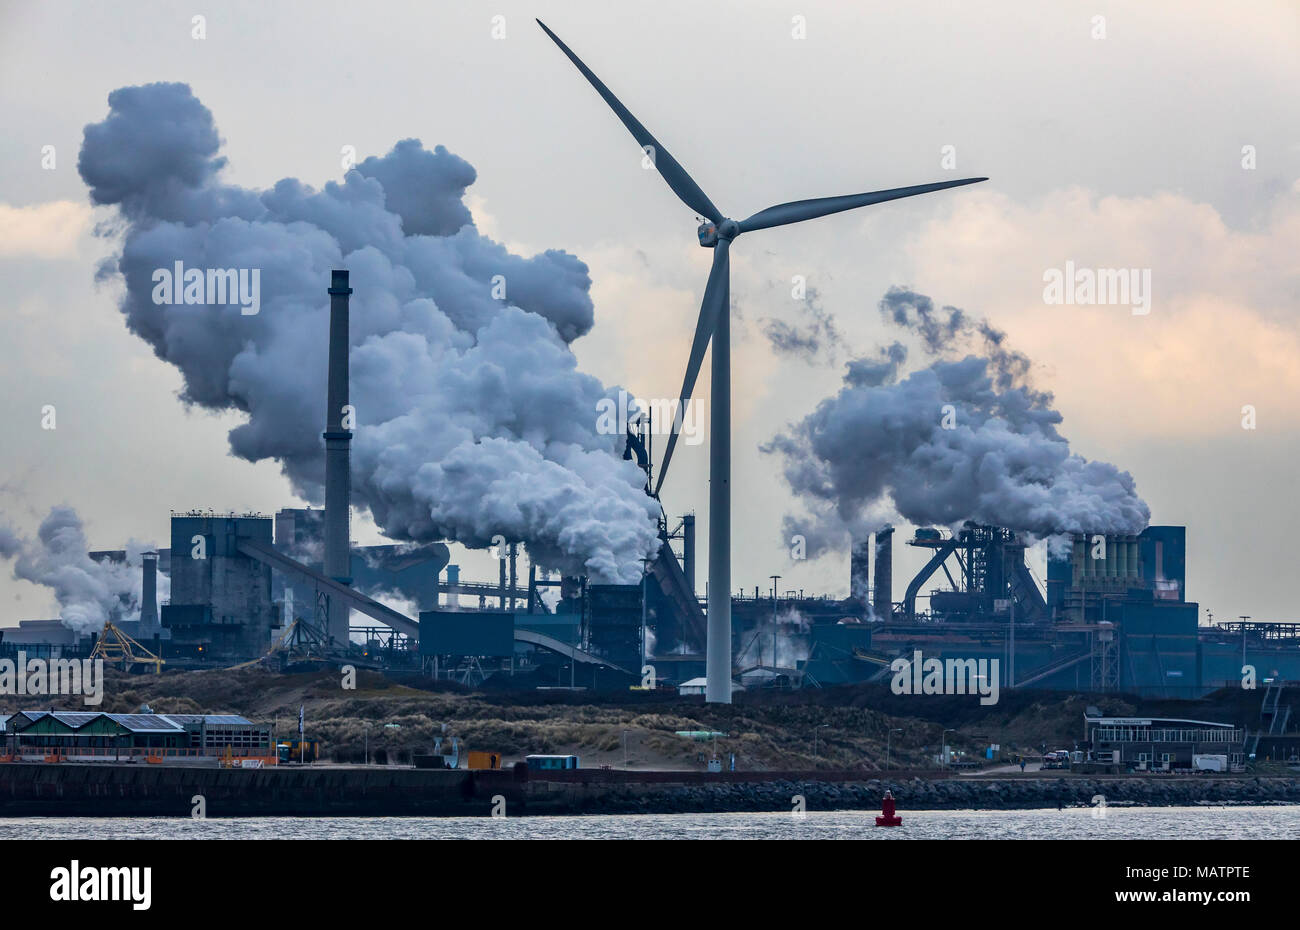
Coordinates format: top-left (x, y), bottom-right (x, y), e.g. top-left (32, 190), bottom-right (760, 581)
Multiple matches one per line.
top-left (537, 20), bottom-right (988, 704)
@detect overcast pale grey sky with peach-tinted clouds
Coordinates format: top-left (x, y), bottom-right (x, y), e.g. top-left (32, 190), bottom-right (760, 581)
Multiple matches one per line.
top-left (0, 0), bottom-right (1300, 624)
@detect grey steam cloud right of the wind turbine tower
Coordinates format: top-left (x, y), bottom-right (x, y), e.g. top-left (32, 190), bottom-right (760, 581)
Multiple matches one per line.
top-left (763, 287), bottom-right (1151, 555)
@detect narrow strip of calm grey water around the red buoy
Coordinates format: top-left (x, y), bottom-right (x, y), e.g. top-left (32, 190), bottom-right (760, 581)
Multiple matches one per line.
top-left (0, 806), bottom-right (1300, 840)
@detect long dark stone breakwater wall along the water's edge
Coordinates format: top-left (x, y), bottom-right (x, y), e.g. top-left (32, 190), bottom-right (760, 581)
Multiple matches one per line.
top-left (0, 764), bottom-right (1300, 817)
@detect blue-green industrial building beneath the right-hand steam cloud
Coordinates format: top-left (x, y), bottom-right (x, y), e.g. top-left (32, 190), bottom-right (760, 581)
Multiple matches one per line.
top-left (852, 524), bottom-right (1300, 697)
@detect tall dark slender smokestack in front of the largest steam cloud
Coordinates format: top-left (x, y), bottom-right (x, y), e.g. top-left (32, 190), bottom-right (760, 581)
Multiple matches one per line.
top-left (325, 269), bottom-right (352, 645)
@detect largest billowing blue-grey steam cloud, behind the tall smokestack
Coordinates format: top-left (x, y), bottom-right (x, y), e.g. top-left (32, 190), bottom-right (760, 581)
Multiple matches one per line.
top-left (78, 83), bottom-right (659, 581)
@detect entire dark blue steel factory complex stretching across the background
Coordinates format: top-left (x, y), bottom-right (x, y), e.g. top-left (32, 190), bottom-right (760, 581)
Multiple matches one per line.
top-left (0, 271), bottom-right (1300, 707)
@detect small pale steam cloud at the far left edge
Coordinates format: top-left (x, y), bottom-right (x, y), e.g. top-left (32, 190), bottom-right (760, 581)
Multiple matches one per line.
top-left (0, 507), bottom-right (170, 633)
